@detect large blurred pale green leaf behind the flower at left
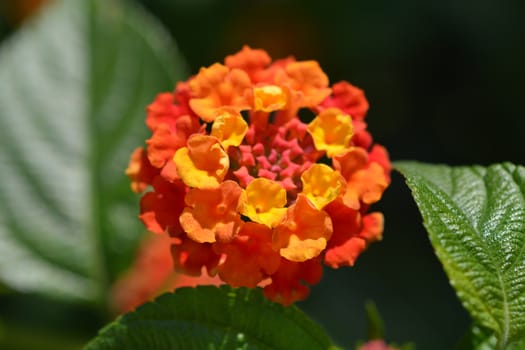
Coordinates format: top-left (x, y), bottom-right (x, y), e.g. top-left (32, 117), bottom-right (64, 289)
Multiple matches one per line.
top-left (0, 0), bottom-right (186, 302)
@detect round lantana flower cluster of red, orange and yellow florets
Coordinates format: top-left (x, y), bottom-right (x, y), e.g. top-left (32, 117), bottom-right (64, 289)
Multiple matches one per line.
top-left (126, 46), bottom-right (390, 305)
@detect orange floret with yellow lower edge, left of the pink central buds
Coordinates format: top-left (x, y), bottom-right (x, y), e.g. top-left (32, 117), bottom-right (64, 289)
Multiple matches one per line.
top-left (173, 134), bottom-right (230, 188)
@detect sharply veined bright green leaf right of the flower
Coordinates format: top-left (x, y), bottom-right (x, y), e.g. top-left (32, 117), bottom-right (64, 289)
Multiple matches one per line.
top-left (395, 162), bottom-right (525, 349)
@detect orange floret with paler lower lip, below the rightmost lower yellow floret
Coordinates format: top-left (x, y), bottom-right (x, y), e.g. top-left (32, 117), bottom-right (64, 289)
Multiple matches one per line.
top-left (273, 194), bottom-right (332, 262)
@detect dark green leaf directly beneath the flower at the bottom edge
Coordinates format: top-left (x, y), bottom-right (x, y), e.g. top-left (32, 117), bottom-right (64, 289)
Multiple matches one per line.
top-left (87, 286), bottom-right (336, 350)
